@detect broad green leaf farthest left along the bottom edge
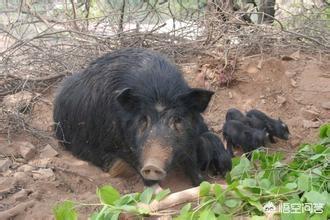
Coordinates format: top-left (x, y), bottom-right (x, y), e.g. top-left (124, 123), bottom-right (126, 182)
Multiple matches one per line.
top-left (53, 201), bottom-right (78, 220)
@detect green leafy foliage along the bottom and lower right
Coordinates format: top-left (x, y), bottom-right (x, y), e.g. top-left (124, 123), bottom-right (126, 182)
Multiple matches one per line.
top-left (54, 124), bottom-right (330, 220)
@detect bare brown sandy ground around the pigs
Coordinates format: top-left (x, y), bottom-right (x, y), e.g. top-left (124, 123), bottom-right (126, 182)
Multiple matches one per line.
top-left (0, 50), bottom-right (330, 220)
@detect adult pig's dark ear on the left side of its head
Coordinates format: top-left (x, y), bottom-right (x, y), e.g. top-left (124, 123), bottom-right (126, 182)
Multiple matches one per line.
top-left (116, 88), bottom-right (139, 112)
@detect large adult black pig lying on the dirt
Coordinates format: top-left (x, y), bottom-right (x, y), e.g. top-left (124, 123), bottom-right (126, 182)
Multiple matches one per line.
top-left (54, 48), bottom-right (229, 185)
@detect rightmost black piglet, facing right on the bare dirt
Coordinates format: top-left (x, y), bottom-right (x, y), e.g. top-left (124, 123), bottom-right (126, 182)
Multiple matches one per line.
top-left (246, 109), bottom-right (290, 143)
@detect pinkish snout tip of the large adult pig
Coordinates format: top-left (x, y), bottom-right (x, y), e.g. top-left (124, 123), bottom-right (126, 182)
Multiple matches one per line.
top-left (140, 159), bottom-right (166, 180)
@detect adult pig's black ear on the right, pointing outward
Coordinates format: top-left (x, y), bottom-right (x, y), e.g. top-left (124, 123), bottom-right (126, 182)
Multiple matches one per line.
top-left (178, 89), bottom-right (214, 112)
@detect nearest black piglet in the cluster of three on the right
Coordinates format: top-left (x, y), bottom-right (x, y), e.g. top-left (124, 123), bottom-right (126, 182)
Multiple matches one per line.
top-left (222, 120), bottom-right (269, 156)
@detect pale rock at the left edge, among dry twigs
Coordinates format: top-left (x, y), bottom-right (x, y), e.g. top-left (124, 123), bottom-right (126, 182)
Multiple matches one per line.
top-left (2, 91), bottom-right (33, 112)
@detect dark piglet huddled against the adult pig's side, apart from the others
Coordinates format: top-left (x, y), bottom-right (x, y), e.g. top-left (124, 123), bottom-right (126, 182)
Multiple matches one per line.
top-left (197, 132), bottom-right (232, 176)
